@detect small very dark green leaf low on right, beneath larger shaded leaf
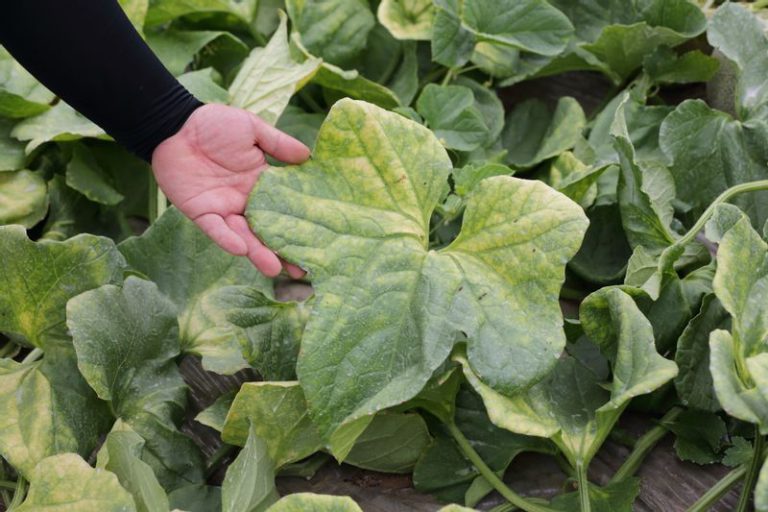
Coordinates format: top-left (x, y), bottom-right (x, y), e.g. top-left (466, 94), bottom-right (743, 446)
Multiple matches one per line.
top-left (668, 410), bottom-right (727, 464)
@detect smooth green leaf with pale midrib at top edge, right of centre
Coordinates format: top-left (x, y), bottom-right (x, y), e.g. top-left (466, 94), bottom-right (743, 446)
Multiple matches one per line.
top-left (432, 0), bottom-right (573, 67)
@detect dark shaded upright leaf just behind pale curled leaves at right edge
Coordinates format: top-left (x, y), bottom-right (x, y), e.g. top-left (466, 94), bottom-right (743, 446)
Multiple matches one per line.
top-left (675, 294), bottom-right (731, 411)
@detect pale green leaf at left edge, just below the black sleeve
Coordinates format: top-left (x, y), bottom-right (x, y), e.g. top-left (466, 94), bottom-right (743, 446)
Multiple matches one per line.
top-left (0, 47), bottom-right (54, 119)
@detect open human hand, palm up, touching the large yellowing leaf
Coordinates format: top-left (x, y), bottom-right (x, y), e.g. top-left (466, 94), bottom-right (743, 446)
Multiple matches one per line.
top-left (152, 104), bottom-right (309, 278)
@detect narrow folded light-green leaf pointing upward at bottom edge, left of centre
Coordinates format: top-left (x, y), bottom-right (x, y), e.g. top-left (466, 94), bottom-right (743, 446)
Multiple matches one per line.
top-left (221, 425), bottom-right (280, 512)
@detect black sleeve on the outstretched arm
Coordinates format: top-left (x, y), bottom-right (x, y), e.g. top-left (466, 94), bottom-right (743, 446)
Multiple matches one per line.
top-left (0, 0), bottom-right (201, 161)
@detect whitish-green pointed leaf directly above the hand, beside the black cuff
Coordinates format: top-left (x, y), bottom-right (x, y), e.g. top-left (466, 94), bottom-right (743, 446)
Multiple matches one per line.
top-left (229, 13), bottom-right (322, 124)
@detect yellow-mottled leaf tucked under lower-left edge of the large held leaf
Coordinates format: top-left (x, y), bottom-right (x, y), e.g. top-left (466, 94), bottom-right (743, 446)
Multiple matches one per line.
top-left (222, 382), bottom-right (322, 468)
